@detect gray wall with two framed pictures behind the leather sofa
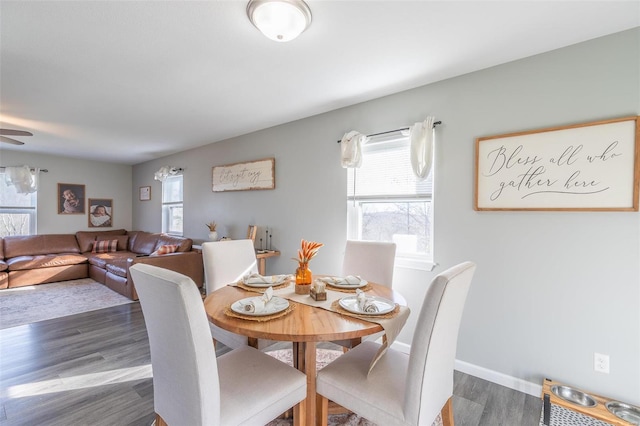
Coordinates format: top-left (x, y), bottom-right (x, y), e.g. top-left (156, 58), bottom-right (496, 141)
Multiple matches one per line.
top-left (0, 151), bottom-right (132, 234)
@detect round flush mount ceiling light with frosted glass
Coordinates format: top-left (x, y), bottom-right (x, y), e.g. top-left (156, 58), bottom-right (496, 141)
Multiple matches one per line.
top-left (247, 0), bottom-right (311, 41)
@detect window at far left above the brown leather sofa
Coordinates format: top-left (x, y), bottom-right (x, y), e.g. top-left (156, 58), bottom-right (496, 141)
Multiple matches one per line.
top-left (0, 171), bottom-right (37, 237)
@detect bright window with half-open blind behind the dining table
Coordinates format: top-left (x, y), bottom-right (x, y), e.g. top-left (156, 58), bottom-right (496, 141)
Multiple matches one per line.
top-left (347, 132), bottom-right (433, 269)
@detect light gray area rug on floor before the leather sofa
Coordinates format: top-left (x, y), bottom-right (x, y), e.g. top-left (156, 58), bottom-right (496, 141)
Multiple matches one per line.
top-left (0, 278), bottom-right (132, 330)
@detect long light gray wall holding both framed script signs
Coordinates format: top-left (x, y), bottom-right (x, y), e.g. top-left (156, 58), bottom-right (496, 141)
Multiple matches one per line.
top-left (133, 29), bottom-right (640, 404)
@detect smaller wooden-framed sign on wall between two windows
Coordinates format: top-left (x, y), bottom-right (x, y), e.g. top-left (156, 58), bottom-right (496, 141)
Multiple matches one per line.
top-left (213, 158), bottom-right (276, 192)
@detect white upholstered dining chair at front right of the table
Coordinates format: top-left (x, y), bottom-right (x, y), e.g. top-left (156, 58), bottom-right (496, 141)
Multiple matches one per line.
top-left (316, 262), bottom-right (476, 426)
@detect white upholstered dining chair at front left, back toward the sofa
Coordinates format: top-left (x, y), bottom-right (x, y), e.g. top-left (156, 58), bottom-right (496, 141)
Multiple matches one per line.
top-left (131, 264), bottom-right (307, 426)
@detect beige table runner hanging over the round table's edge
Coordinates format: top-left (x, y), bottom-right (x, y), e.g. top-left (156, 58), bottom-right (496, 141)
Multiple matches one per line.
top-left (232, 284), bottom-right (411, 373)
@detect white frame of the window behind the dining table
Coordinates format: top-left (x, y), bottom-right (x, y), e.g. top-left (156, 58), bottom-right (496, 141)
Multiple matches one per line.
top-left (347, 132), bottom-right (436, 271)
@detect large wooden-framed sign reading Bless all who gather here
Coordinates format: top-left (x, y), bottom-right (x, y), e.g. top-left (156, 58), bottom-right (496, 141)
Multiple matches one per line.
top-left (474, 116), bottom-right (640, 211)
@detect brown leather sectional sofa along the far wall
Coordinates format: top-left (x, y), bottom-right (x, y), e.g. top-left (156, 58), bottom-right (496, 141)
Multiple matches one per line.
top-left (0, 229), bottom-right (204, 300)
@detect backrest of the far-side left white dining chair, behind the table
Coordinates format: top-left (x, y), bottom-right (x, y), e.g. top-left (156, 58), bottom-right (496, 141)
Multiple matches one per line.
top-left (202, 239), bottom-right (258, 294)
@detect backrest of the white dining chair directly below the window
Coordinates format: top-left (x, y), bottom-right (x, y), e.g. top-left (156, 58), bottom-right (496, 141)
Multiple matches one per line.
top-left (342, 240), bottom-right (396, 287)
